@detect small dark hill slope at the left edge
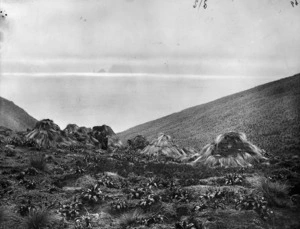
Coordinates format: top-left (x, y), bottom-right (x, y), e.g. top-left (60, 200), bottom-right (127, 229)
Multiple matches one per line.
top-left (0, 97), bottom-right (37, 131)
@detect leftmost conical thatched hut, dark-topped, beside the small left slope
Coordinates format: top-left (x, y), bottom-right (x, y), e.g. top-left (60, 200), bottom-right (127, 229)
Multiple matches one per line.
top-left (25, 119), bottom-right (71, 148)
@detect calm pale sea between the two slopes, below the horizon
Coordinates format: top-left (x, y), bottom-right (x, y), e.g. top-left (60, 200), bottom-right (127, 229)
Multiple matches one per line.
top-left (0, 73), bottom-right (279, 132)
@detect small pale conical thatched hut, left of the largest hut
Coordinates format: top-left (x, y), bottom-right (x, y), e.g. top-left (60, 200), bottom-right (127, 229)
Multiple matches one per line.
top-left (141, 133), bottom-right (186, 159)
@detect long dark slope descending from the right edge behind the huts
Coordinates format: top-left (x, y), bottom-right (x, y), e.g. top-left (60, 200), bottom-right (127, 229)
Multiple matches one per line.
top-left (118, 74), bottom-right (300, 153)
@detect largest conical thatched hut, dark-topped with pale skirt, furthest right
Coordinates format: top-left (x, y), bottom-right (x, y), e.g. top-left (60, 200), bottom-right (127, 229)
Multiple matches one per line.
top-left (191, 132), bottom-right (267, 167)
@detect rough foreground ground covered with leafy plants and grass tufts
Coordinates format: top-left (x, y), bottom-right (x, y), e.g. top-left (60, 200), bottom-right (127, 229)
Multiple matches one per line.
top-left (0, 135), bottom-right (300, 229)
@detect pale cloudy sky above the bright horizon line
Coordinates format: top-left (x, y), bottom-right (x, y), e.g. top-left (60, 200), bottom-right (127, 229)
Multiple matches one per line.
top-left (0, 0), bottom-right (300, 76)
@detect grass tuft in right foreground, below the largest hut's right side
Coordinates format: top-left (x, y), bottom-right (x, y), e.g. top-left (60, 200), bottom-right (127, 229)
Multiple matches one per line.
top-left (257, 177), bottom-right (289, 207)
